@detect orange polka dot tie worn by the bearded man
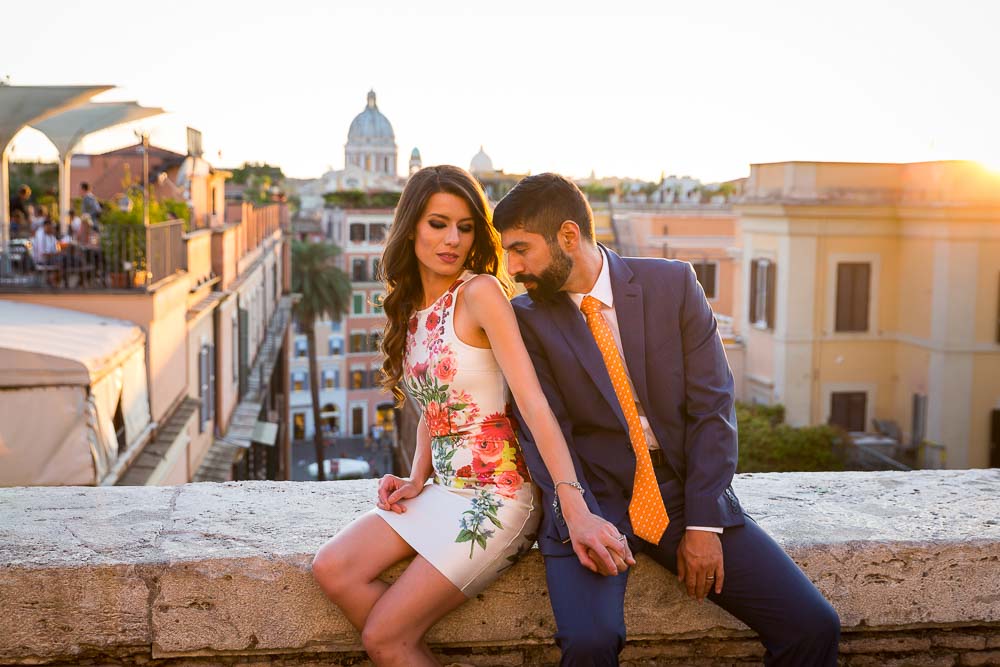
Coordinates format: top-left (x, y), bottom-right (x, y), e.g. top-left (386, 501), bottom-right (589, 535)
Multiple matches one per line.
top-left (580, 296), bottom-right (670, 544)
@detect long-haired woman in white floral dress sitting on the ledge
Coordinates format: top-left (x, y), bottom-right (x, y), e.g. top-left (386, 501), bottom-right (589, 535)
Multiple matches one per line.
top-left (313, 166), bottom-right (634, 665)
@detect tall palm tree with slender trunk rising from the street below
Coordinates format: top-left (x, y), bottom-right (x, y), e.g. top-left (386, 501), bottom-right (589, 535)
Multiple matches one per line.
top-left (292, 241), bottom-right (351, 482)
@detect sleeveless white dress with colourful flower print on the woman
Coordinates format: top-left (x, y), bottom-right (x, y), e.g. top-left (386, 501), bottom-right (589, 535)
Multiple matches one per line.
top-left (373, 272), bottom-right (541, 597)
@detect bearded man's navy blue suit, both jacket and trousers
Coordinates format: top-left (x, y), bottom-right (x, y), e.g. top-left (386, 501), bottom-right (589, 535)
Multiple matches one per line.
top-left (513, 249), bottom-right (840, 665)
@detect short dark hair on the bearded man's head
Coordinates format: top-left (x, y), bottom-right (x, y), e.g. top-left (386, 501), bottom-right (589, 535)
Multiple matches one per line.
top-left (493, 173), bottom-right (594, 243)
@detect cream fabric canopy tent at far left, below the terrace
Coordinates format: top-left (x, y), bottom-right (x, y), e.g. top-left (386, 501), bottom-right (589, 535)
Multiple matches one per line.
top-left (0, 300), bottom-right (150, 486)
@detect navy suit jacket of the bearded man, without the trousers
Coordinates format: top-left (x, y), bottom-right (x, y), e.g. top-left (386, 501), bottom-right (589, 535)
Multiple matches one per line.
top-left (512, 248), bottom-right (743, 555)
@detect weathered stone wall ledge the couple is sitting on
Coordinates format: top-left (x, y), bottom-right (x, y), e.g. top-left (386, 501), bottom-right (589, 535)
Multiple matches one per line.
top-left (0, 470), bottom-right (1000, 667)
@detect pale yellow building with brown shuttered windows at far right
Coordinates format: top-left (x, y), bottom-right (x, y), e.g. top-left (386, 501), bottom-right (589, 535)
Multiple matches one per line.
top-left (737, 161), bottom-right (1000, 468)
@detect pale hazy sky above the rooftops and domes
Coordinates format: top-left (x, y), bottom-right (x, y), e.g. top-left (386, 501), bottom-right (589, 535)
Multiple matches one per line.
top-left (0, 0), bottom-right (1000, 181)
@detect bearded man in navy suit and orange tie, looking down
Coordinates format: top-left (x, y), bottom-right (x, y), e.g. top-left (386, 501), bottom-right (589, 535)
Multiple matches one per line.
top-left (493, 174), bottom-right (840, 666)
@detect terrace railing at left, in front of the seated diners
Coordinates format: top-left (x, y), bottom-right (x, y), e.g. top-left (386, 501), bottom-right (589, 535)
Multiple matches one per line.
top-left (0, 220), bottom-right (185, 290)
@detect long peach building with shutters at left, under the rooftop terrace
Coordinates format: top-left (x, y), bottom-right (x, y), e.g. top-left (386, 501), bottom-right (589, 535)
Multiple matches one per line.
top-left (0, 180), bottom-right (291, 485)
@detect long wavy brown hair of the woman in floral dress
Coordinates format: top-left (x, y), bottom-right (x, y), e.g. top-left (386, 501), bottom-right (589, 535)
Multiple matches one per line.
top-left (378, 165), bottom-right (513, 404)
